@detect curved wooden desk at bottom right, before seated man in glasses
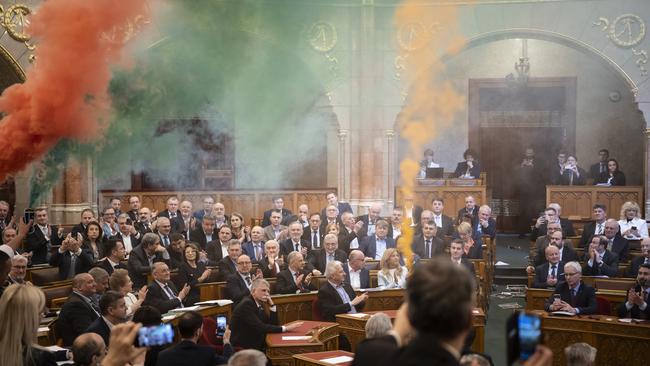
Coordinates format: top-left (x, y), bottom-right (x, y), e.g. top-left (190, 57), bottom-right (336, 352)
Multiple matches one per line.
top-left (536, 311), bottom-right (650, 366)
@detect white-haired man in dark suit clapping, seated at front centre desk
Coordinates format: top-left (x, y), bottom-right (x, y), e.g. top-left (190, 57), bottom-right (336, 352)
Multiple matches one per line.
top-left (316, 261), bottom-right (368, 322)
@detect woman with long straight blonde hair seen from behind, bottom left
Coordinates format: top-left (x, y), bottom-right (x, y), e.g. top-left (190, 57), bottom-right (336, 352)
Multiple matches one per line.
top-left (0, 284), bottom-right (56, 366)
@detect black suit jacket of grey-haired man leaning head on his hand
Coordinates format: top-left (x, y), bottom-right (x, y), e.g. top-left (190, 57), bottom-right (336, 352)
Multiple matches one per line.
top-left (230, 296), bottom-right (282, 352)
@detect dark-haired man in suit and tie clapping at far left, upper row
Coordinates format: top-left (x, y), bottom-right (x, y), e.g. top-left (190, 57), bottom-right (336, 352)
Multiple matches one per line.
top-left (25, 208), bottom-right (63, 264)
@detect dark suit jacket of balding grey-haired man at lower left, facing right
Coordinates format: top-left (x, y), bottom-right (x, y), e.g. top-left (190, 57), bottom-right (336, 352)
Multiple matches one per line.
top-left (56, 292), bottom-right (99, 347)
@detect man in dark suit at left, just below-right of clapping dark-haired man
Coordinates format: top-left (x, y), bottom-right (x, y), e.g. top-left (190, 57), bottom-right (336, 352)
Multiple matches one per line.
top-left (50, 232), bottom-right (93, 280)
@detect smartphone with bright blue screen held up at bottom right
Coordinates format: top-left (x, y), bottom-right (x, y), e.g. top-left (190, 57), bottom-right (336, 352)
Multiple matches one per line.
top-left (506, 312), bottom-right (542, 365)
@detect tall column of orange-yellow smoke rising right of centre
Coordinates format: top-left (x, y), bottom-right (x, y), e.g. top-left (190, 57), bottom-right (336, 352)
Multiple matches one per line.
top-left (395, 0), bottom-right (465, 264)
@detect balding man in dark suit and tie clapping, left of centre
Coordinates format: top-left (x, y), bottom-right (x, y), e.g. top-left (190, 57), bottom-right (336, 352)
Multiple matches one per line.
top-left (142, 262), bottom-right (190, 314)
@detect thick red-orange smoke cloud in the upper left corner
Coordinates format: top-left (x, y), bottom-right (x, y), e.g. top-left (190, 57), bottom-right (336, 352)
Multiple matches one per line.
top-left (0, 0), bottom-right (146, 180)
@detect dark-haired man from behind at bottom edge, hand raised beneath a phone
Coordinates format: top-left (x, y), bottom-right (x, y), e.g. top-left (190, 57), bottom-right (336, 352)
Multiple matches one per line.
top-left (156, 311), bottom-right (234, 366)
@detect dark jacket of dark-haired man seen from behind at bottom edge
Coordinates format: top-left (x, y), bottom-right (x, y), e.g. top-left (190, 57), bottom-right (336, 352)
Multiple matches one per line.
top-left (156, 339), bottom-right (234, 366)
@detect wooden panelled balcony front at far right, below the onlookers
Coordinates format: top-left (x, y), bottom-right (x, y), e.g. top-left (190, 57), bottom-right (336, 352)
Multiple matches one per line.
top-left (544, 186), bottom-right (644, 219)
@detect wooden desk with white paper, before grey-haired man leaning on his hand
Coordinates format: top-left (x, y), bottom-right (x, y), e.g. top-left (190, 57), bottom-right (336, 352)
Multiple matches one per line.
top-left (266, 321), bottom-right (339, 366)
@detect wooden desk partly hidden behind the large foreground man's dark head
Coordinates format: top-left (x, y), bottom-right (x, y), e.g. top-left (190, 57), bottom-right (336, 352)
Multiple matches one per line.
top-left (336, 309), bottom-right (485, 353)
